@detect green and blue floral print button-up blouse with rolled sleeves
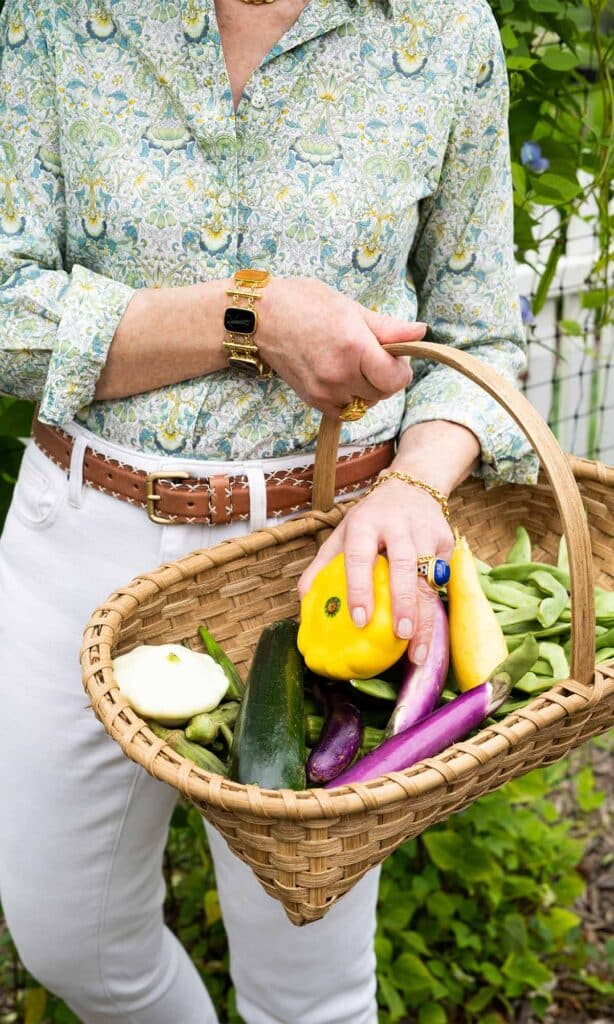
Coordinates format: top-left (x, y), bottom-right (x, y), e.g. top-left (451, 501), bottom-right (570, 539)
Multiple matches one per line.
top-left (0, 0), bottom-right (535, 480)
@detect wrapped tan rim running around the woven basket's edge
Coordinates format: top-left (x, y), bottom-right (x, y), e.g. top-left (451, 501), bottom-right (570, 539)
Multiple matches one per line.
top-left (81, 468), bottom-right (614, 821)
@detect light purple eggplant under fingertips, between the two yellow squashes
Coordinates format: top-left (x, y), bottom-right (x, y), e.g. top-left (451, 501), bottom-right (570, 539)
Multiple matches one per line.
top-left (386, 597), bottom-right (450, 736)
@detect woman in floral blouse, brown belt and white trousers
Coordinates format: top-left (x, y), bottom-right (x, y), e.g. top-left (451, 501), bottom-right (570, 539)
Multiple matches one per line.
top-left (0, 0), bottom-right (534, 1024)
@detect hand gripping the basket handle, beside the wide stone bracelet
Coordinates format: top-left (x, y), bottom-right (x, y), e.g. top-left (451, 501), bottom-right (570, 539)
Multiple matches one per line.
top-left (256, 278), bottom-right (426, 419)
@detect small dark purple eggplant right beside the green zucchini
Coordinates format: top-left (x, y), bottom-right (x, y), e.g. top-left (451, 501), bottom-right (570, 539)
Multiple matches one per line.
top-left (307, 685), bottom-right (362, 782)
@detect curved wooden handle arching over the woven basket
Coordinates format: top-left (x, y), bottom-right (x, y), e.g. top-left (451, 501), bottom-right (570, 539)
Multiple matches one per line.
top-left (313, 341), bottom-right (595, 685)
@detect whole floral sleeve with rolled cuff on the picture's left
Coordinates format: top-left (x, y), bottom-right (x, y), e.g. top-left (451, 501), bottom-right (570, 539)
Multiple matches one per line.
top-left (0, 0), bottom-right (134, 426)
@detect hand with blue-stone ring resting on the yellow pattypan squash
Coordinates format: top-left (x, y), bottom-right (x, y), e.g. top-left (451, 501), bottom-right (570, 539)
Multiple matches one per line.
top-left (298, 477), bottom-right (454, 665)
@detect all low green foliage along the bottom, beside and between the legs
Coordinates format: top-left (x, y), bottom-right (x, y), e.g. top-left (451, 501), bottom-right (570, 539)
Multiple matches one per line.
top-left (0, 753), bottom-right (614, 1024)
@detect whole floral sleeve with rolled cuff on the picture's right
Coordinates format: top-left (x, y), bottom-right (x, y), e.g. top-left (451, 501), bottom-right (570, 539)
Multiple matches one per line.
top-left (401, 3), bottom-right (537, 482)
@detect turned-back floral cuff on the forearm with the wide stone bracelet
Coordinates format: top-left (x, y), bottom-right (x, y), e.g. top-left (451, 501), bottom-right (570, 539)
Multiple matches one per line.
top-left (39, 264), bottom-right (135, 427)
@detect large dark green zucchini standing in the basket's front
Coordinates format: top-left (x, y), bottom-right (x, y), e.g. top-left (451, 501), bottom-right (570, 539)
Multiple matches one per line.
top-left (229, 618), bottom-right (307, 790)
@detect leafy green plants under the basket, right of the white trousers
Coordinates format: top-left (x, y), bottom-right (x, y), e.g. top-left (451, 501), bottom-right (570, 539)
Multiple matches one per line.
top-left (378, 765), bottom-right (586, 1024)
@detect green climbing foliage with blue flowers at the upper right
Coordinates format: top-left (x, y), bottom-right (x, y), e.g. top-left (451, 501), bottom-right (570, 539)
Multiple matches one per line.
top-left (491, 0), bottom-right (614, 331)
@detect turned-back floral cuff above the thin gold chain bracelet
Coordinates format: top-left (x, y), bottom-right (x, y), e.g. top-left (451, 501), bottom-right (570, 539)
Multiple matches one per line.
top-left (400, 368), bottom-right (539, 486)
